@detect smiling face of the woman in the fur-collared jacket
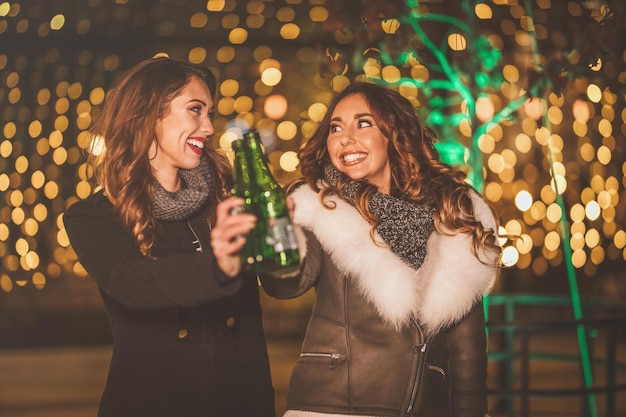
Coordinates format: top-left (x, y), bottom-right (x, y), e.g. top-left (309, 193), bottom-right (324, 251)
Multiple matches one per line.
top-left (326, 94), bottom-right (391, 194)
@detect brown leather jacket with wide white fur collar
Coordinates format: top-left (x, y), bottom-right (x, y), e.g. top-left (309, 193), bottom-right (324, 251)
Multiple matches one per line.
top-left (262, 187), bottom-right (497, 417)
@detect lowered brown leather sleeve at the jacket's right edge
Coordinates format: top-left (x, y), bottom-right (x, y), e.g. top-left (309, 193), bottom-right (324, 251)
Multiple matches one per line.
top-left (448, 301), bottom-right (487, 417)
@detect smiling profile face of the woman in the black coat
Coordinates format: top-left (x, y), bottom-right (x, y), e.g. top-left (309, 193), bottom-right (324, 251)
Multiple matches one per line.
top-left (149, 77), bottom-right (214, 191)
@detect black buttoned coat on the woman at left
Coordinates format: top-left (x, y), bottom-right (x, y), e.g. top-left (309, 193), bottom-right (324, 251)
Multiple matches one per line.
top-left (64, 192), bottom-right (275, 417)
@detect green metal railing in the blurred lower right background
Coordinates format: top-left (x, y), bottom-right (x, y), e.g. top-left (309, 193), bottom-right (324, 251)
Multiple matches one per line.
top-left (487, 295), bottom-right (626, 417)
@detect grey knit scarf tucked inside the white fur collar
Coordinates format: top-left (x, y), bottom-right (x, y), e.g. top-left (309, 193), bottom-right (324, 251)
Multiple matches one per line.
top-left (324, 165), bottom-right (435, 270)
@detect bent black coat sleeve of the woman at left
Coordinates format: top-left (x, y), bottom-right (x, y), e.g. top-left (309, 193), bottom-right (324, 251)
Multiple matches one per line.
top-left (63, 195), bottom-right (241, 309)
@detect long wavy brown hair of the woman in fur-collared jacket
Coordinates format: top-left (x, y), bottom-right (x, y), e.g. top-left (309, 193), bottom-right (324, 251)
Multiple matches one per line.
top-left (298, 82), bottom-right (499, 254)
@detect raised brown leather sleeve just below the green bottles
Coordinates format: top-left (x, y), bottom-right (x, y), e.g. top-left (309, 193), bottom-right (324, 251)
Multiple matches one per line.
top-left (259, 229), bottom-right (322, 299)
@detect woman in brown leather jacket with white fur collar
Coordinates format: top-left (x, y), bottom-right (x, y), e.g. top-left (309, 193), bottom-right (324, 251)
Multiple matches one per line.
top-left (262, 83), bottom-right (500, 417)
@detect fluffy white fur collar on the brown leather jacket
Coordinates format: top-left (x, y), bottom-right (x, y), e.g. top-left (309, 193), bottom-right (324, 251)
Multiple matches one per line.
top-left (291, 186), bottom-right (498, 334)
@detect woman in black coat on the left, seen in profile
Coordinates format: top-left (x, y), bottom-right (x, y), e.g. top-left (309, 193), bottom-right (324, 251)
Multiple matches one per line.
top-left (64, 58), bottom-right (275, 417)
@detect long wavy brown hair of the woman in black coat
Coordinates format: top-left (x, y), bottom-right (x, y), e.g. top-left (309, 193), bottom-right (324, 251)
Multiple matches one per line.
top-left (90, 57), bottom-right (232, 256)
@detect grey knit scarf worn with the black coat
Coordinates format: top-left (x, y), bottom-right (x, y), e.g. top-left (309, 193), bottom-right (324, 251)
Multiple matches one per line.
top-left (152, 156), bottom-right (213, 221)
